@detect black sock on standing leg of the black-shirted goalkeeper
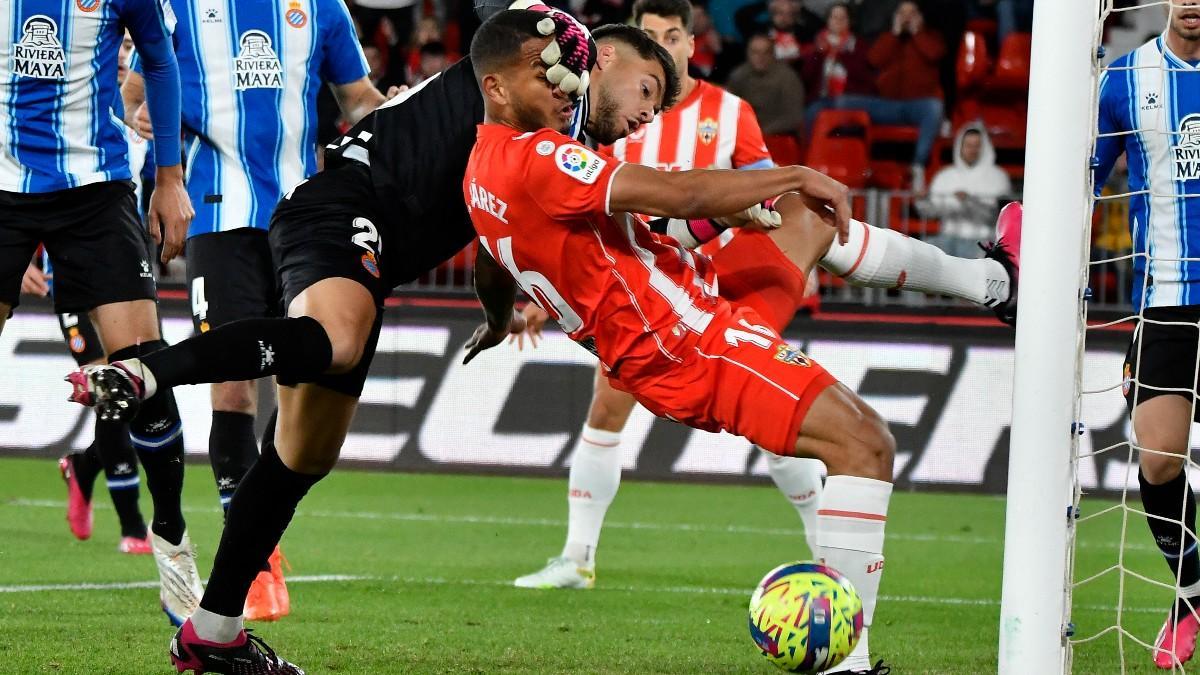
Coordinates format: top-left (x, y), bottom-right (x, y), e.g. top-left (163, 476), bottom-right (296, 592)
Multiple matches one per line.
top-left (200, 416), bottom-right (325, 616)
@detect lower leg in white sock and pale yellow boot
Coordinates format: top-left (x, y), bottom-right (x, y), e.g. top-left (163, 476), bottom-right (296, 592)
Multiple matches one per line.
top-left (514, 365), bottom-right (637, 589)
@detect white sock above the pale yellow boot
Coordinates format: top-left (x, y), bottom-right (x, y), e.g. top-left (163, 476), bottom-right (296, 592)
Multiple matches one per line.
top-left (563, 424), bottom-right (620, 568)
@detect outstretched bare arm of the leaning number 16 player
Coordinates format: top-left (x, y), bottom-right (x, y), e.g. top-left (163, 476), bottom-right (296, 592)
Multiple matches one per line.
top-left (610, 165), bottom-right (850, 241)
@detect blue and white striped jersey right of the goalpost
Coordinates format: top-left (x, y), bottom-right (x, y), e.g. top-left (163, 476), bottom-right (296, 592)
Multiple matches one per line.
top-left (1093, 36), bottom-right (1200, 310)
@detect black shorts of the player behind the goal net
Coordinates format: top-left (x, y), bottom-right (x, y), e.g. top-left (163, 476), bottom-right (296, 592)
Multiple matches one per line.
top-left (1122, 305), bottom-right (1200, 422)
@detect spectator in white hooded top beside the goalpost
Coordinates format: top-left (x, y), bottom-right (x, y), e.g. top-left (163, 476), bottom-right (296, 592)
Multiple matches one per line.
top-left (918, 125), bottom-right (1013, 258)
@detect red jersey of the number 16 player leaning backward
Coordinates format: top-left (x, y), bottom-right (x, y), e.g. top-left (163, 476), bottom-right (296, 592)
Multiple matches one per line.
top-left (463, 124), bottom-right (720, 374)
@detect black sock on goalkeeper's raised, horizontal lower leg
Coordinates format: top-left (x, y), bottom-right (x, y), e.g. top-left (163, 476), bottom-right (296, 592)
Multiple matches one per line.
top-left (142, 316), bottom-right (334, 388)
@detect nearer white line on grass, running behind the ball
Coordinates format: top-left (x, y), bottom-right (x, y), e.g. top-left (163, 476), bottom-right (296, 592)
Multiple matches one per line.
top-left (0, 574), bottom-right (1162, 614)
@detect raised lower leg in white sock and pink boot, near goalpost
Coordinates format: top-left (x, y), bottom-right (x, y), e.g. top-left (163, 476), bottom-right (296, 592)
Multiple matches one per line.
top-left (821, 196), bottom-right (1021, 323)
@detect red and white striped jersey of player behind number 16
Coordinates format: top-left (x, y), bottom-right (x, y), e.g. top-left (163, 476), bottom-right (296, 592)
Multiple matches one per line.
top-left (604, 79), bottom-right (774, 171)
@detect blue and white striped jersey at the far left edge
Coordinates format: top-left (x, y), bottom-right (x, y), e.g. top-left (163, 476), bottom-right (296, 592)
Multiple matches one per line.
top-left (0, 0), bottom-right (180, 192)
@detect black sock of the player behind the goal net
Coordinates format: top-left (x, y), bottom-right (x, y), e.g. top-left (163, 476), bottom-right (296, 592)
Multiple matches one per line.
top-left (1138, 468), bottom-right (1200, 610)
